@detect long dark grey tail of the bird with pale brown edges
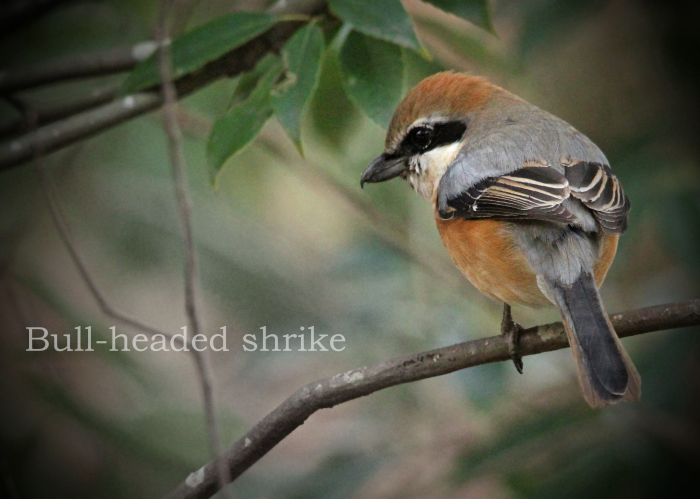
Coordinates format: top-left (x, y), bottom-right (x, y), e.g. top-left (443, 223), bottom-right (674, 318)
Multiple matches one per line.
top-left (547, 271), bottom-right (641, 407)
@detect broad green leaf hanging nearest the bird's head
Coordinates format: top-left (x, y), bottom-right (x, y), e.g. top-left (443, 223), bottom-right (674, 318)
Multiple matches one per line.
top-left (340, 31), bottom-right (403, 128)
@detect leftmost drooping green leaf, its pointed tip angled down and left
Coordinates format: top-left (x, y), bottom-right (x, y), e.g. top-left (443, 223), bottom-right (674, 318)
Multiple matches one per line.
top-left (207, 59), bottom-right (282, 182)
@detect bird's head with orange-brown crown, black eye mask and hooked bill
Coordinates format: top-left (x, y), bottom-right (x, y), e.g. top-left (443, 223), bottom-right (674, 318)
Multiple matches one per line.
top-left (361, 72), bottom-right (498, 200)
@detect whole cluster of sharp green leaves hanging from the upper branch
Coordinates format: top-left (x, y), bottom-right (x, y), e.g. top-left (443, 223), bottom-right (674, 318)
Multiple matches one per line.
top-left (123, 0), bottom-right (492, 182)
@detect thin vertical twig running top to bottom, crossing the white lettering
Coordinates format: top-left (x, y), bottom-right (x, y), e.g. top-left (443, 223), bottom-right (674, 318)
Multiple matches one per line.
top-left (156, 0), bottom-right (230, 496)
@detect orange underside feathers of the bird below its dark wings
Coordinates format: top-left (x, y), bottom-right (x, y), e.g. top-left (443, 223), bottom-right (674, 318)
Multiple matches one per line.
top-left (436, 217), bottom-right (618, 307)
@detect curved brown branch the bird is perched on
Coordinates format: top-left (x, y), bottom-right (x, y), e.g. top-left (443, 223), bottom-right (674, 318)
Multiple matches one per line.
top-left (167, 299), bottom-right (700, 499)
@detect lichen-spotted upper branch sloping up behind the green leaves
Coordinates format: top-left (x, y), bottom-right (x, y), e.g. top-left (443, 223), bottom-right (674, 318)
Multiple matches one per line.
top-left (0, 0), bottom-right (326, 172)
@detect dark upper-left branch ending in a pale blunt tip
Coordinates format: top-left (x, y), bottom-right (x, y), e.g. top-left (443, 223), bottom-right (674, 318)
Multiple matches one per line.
top-left (0, 41), bottom-right (157, 95)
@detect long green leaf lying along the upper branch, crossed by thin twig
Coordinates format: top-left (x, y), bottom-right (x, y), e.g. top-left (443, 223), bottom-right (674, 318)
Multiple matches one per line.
top-left (123, 12), bottom-right (278, 93)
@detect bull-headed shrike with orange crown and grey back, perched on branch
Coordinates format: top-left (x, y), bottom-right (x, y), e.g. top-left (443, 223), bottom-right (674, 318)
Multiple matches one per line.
top-left (360, 71), bottom-right (641, 408)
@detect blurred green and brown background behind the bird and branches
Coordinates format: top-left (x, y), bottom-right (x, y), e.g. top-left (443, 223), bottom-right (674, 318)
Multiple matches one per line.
top-left (0, 0), bottom-right (700, 499)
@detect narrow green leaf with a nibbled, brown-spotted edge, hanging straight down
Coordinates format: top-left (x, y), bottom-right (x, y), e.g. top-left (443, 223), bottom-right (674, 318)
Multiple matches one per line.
top-left (272, 23), bottom-right (324, 155)
